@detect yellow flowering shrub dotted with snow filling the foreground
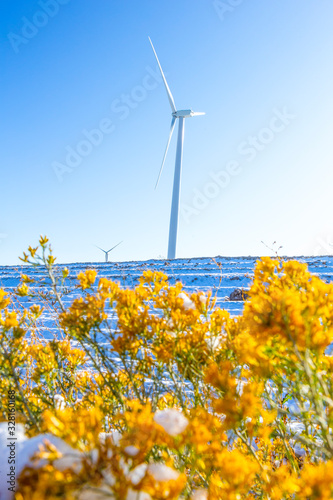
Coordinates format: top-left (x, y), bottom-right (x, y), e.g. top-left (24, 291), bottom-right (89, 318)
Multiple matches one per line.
top-left (0, 238), bottom-right (333, 500)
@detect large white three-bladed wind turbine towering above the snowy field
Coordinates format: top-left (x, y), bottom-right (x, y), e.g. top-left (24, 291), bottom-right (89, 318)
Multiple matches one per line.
top-left (148, 37), bottom-right (206, 259)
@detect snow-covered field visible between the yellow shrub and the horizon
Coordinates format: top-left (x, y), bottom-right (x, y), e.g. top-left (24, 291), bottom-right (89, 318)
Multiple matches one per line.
top-left (0, 256), bottom-right (333, 330)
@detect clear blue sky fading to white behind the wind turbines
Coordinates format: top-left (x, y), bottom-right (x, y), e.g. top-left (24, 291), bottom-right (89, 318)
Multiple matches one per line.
top-left (0, 0), bottom-right (333, 265)
